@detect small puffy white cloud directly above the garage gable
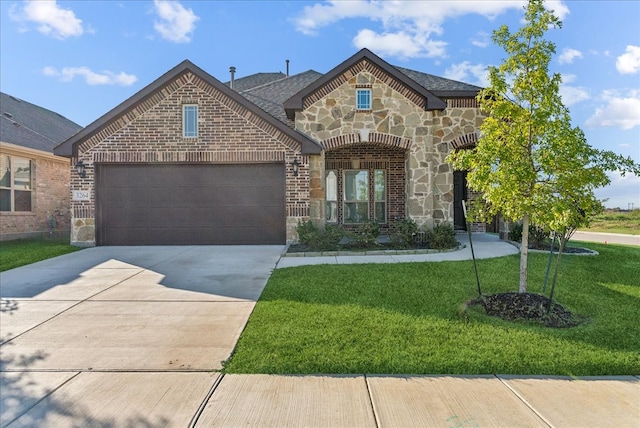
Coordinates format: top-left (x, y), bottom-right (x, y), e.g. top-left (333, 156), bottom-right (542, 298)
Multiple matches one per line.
top-left (153, 0), bottom-right (200, 43)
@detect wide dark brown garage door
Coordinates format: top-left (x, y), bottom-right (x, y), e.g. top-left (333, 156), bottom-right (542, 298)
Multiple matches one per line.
top-left (96, 164), bottom-right (285, 245)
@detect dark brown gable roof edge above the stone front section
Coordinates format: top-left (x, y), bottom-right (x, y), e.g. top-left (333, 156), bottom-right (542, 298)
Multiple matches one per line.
top-left (284, 48), bottom-right (447, 119)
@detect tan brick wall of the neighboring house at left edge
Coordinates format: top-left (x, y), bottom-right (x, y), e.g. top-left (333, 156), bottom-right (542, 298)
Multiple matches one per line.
top-left (0, 144), bottom-right (70, 241)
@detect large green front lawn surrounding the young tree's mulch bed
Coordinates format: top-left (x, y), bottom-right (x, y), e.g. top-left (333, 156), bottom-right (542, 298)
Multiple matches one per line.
top-left (225, 244), bottom-right (640, 376)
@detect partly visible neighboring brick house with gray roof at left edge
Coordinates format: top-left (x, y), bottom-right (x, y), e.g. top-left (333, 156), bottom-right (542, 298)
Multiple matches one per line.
top-left (0, 93), bottom-right (82, 241)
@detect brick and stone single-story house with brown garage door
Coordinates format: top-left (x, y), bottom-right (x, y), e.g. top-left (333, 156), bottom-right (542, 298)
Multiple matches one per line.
top-left (54, 49), bottom-right (484, 245)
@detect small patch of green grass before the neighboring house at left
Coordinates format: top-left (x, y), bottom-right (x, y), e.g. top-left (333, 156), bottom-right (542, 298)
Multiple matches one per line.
top-left (0, 239), bottom-right (80, 272)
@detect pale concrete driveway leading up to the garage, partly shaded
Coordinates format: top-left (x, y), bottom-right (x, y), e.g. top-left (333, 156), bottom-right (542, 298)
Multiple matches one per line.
top-left (0, 246), bottom-right (283, 427)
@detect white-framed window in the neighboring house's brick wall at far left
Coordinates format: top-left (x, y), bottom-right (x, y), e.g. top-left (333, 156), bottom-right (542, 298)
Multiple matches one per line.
top-left (0, 155), bottom-right (33, 212)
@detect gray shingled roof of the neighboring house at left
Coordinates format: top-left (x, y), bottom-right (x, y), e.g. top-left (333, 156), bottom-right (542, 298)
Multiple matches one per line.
top-left (0, 92), bottom-right (82, 153)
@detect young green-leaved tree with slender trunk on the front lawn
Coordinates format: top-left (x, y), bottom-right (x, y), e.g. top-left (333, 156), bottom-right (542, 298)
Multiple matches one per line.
top-left (447, 0), bottom-right (640, 293)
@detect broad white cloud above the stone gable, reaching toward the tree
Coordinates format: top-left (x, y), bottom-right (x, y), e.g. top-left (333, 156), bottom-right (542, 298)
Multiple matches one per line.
top-left (293, 0), bottom-right (536, 58)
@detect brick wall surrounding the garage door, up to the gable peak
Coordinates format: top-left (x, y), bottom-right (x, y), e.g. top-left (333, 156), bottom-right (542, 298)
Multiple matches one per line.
top-left (71, 73), bottom-right (309, 246)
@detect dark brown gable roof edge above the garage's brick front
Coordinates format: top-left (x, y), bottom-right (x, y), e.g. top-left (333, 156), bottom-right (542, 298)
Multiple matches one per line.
top-left (54, 60), bottom-right (322, 157)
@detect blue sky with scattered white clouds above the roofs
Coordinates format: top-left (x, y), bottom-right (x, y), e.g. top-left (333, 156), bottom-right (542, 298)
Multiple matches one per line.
top-left (0, 0), bottom-right (640, 209)
